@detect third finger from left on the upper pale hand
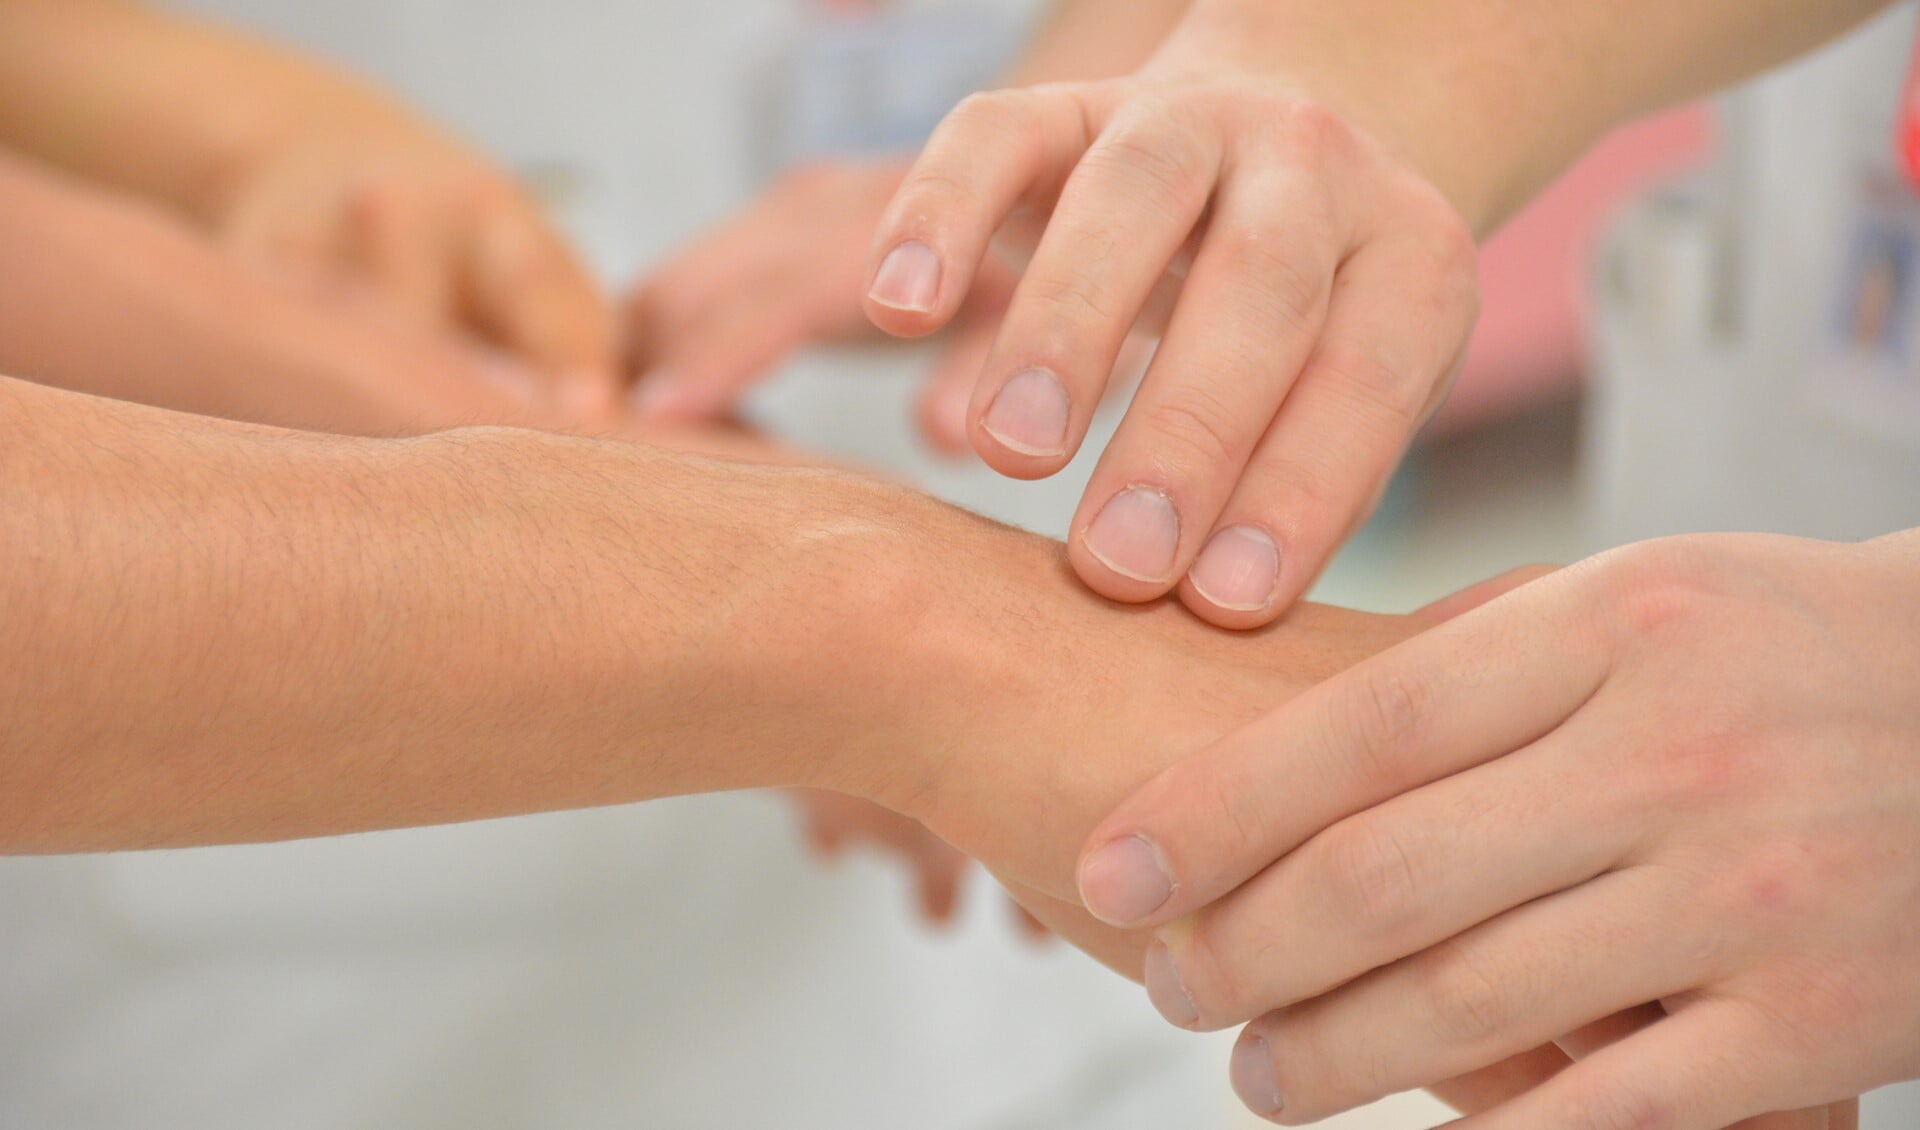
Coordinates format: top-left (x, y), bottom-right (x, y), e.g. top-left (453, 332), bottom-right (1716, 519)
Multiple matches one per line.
top-left (1069, 163), bottom-right (1350, 600)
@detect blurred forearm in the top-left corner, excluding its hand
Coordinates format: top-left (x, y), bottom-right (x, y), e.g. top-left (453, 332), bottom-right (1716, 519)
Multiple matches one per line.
top-left (0, 0), bottom-right (453, 219)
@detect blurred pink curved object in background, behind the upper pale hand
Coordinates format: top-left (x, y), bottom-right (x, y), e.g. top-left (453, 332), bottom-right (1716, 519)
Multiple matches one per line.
top-left (1427, 106), bottom-right (1713, 436)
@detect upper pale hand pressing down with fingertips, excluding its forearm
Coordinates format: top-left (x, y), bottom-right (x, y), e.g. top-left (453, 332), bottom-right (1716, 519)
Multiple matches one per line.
top-left (868, 8), bottom-right (1478, 627)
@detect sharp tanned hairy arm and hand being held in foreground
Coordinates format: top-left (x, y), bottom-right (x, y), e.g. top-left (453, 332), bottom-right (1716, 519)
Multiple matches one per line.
top-left (0, 370), bottom-right (1411, 934)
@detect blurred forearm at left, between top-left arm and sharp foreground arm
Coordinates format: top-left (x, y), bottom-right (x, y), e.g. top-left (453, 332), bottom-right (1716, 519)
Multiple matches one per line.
top-left (0, 153), bottom-right (541, 436)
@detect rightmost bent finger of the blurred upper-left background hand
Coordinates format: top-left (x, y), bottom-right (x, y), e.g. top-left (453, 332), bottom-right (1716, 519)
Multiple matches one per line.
top-left (465, 201), bottom-right (618, 412)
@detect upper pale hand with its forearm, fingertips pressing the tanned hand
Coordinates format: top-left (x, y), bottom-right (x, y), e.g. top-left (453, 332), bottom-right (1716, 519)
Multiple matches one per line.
top-left (868, 0), bottom-right (1884, 627)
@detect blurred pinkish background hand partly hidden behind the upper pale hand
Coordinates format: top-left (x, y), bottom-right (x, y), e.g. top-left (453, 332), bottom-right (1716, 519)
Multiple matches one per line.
top-left (628, 163), bottom-right (1012, 451)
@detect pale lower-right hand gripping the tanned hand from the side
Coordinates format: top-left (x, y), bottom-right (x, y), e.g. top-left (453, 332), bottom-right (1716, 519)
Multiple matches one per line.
top-left (1081, 533), bottom-right (1920, 1130)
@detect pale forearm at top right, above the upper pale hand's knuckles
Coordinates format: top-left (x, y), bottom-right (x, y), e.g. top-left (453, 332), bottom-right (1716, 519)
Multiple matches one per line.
top-left (1164, 0), bottom-right (1889, 232)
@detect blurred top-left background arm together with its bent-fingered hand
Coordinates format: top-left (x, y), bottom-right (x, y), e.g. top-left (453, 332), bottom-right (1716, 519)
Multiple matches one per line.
top-left (0, 0), bottom-right (622, 404)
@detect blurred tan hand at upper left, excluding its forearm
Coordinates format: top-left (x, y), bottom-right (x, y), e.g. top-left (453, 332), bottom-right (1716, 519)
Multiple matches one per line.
top-left (207, 92), bottom-right (620, 404)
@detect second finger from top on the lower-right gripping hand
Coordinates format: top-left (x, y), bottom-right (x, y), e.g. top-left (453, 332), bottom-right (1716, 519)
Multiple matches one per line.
top-left (1154, 729), bottom-right (1657, 1028)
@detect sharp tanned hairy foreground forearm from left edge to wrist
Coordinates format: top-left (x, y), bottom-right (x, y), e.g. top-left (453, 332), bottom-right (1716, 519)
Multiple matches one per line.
top-left (0, 374), bottom-right (929, 852)
